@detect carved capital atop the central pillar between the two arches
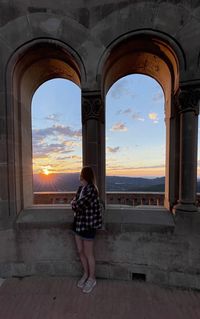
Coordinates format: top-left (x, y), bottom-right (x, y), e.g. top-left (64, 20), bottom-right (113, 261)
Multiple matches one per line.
top-left (82, 91), bottom-right (105, 123)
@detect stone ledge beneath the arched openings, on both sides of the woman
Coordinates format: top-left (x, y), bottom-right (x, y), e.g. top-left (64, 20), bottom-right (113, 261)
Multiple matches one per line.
top-left (15, 205), bottom-right (175, 232)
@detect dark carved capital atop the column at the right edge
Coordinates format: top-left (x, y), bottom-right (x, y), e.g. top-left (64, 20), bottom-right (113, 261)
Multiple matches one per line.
top-left (175, 87), bottom-right (200, 115)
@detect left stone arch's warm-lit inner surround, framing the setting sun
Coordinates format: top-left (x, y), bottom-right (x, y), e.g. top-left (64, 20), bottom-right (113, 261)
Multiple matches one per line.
top-left (7, 39), bottom-right (85, 214)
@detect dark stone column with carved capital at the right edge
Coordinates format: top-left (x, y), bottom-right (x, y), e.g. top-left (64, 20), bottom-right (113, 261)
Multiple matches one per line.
top-left (175, 87), bottom-right (200, 212)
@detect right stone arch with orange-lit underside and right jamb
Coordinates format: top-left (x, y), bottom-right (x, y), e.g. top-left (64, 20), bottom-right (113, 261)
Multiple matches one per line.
top-left (99, 34), bottom-right (180, 209)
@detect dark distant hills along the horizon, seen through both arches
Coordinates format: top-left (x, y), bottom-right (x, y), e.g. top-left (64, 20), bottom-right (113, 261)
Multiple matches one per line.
top-left (33, 173), bottom-right (165, 192)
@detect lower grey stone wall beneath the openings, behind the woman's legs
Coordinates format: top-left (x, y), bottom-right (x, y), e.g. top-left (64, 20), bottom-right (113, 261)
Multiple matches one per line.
top-left (0, 208), bottom-right (200, 289)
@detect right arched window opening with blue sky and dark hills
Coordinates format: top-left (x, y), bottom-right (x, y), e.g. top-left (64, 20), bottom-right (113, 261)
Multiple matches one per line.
top-left (106, 74), bottom-right (166, 204)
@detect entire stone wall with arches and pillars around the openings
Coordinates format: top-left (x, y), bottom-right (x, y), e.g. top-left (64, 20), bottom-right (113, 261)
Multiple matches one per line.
top-left (0, 0), bottom-right (200, 289)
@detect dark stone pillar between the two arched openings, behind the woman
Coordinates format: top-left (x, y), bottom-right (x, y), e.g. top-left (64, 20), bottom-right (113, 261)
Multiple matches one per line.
top-left (82, 91), bottom-right (105, 202)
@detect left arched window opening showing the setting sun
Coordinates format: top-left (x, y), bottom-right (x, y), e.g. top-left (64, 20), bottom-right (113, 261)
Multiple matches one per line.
top-left (32, 78), bottom-right (82, 204)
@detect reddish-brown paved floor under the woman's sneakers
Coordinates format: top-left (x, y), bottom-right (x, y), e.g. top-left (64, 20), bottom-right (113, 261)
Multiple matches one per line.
top-left (0, 277), bottom-right (200, 319)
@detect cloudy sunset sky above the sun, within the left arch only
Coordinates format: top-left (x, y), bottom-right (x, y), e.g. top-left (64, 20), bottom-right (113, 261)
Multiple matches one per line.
top-left (32, 79), bottom-right (82, 173)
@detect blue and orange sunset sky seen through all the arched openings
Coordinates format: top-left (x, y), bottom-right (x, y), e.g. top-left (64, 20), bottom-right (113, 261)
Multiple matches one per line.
top-left (32, 74), bottom-right (200, 177)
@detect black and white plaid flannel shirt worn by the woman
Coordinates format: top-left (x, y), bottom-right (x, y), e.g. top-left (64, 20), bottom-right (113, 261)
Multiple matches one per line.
top-left (71, 184), bottom-right (102, 232)
